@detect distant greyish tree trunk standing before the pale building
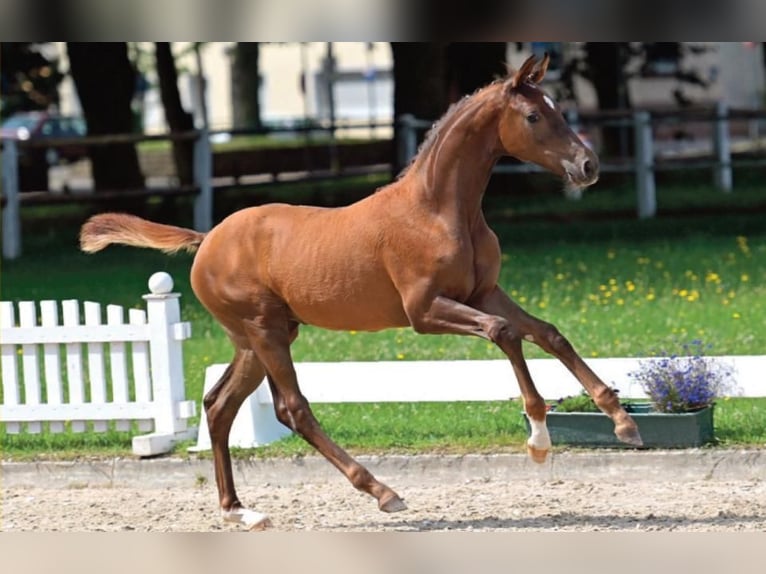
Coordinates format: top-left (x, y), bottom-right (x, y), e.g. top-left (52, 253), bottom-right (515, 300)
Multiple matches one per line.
top-left (231, 42), bottom-right (261, 129)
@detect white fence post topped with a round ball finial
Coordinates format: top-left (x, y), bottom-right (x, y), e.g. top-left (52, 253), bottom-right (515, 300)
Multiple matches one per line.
top-left (133, 271), bottom-right (196, 456)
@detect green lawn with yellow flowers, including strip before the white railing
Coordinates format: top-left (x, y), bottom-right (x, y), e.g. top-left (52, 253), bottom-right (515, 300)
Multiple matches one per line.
top-left (0, 180), bottom-right (766, 456)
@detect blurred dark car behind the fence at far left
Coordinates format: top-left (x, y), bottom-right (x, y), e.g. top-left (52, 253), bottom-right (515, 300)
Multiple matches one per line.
top-left (0, 112), bottom-right (88, 191)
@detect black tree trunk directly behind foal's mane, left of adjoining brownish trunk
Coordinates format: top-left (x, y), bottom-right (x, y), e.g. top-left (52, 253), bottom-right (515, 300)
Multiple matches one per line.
top-left (391, 42), bottom-right (448, 173)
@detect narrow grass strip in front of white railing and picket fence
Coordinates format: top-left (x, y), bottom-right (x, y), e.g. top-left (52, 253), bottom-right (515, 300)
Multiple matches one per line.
top-left (2, 398), bottom-right (766, 461)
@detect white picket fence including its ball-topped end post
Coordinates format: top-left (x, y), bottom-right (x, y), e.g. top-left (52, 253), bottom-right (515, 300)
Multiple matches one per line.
top-left (0, 272), bottom-right (196, 456)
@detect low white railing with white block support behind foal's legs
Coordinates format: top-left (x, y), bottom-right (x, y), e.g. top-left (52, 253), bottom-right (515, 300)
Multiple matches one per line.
top-left (190, 355), bottom-right (766, 451)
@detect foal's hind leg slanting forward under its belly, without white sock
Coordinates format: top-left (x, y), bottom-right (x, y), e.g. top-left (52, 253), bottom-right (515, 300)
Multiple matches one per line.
top-left (245, 320), bottom-right (407, 512)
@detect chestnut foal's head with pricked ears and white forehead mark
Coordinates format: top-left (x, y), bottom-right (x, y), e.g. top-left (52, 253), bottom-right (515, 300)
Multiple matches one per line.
top-left (499, 54), bottom-right (598, 197)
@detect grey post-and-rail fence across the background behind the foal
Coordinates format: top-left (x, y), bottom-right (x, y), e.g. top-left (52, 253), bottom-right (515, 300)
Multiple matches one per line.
top-left (2, 106), bottom-right (766, 259)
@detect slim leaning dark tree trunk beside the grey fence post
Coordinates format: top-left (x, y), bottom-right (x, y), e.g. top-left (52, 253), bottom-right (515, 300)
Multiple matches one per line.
top-left (154, 42), bottom-right (194, 185)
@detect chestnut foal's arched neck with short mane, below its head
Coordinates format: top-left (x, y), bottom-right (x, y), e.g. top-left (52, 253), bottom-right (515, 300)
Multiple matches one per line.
top-left (411, 86), bottom-right (503, 225)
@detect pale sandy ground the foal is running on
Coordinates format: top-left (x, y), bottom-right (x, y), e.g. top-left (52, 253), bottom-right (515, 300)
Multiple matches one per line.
top-left (1, 459), bottom-right (766, 532)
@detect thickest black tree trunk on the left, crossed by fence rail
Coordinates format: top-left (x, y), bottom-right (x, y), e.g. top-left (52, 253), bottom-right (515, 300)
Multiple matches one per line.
top-left (67, 42), bottom-right (144, 191)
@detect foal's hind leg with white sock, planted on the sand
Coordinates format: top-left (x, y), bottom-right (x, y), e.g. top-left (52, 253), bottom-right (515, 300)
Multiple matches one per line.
top-left (204, 349), bottom-right (270, 530)
